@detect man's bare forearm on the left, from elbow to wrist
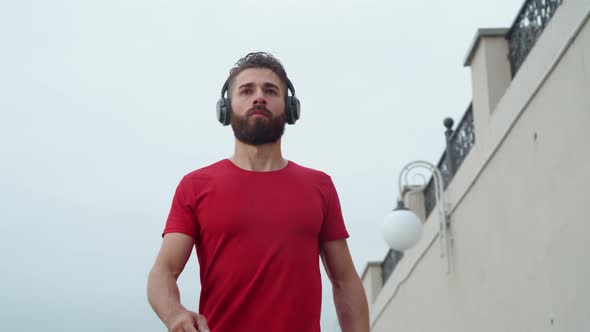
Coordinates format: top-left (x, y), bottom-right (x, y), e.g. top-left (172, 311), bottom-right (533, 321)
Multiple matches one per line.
top-left (147, 268), bottom-right (184, 325)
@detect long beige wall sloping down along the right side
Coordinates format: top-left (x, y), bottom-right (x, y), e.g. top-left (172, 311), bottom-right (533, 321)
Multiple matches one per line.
top-left (370, 0), bottom-right (590, 332)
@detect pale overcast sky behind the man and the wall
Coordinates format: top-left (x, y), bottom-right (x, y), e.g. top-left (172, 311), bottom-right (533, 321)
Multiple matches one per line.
top-left (0, 0), bottom-right (522, 332)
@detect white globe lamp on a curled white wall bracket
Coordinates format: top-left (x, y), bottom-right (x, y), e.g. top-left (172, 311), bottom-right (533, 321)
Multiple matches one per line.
top-left (383, 160), bottom-right (451, 273)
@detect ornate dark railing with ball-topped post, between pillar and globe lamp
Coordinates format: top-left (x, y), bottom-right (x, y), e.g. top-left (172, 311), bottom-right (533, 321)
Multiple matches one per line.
top-left (424, 104), bottom-right (475, 218)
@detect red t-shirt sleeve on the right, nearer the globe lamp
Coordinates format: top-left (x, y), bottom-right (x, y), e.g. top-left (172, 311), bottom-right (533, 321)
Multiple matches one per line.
top-left (320, 178), bottom-right (349, 242)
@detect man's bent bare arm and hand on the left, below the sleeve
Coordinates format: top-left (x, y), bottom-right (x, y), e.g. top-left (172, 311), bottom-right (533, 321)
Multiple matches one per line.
top-left (147, 233), bottom-right (209, 332)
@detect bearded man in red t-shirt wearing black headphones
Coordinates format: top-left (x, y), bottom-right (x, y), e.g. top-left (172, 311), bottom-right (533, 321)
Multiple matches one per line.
top-left (148, 53), bottom-right (369, 332)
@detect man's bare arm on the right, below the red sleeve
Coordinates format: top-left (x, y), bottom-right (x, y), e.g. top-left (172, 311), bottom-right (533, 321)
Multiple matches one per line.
top-left (321, 239), bottom-right (369, 332)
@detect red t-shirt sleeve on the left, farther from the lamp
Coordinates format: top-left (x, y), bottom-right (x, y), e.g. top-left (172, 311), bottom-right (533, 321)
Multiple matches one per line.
top-left (162, 177), bottom-right (199, 240)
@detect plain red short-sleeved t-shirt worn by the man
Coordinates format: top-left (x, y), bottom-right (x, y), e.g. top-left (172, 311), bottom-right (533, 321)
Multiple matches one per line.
top-left (164, 159), bottom-right (348, 332)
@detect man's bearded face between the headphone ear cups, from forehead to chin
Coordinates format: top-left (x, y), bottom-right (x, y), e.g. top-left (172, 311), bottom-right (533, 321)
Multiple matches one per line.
top-left (230, 68), bottom-right (286, 145)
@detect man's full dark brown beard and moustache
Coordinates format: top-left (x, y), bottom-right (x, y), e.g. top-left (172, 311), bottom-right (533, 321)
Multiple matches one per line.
top-left (231, 106), bottom-right (286, 146)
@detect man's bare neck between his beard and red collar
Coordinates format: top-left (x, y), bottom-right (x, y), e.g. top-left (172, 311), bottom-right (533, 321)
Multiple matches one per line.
top-left (230, 139), bottom-right (287, 172)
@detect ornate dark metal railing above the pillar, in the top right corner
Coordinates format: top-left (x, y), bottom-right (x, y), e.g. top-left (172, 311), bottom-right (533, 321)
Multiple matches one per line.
top-left (506, 0), bottom-right (563, 77)
